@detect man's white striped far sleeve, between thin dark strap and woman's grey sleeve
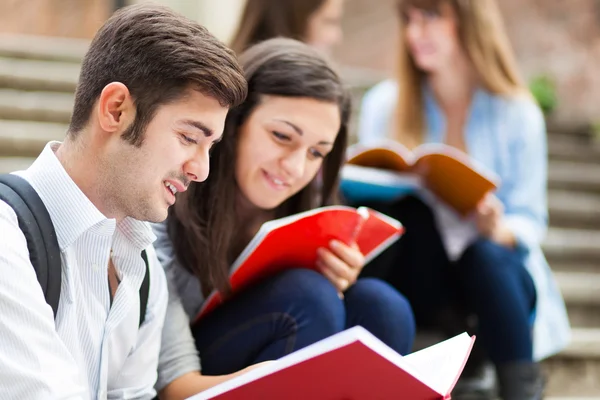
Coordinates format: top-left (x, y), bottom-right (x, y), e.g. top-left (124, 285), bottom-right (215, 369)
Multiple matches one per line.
top-left (108, 246), bottom-right (168, 400)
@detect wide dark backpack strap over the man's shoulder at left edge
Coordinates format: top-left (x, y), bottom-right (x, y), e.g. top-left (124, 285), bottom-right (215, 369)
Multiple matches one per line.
top-left (0, 174), bottom-right (62, 317)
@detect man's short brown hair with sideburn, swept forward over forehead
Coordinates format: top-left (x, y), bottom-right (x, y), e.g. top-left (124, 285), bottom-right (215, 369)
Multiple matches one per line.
top-left (69, 4), bottom-right (247, 146)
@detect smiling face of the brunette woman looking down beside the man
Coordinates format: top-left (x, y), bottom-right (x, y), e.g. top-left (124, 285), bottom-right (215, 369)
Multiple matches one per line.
top-left (235, 96), bottom-right (341, 210)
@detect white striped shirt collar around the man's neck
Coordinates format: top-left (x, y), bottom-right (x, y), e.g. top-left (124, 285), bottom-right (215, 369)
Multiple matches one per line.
top-left (22, 141), bottom-right (156, 251)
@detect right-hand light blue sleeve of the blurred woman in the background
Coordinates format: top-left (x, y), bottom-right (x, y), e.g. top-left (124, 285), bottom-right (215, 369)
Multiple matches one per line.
top-left (502, 99), bottom-right (548, 249)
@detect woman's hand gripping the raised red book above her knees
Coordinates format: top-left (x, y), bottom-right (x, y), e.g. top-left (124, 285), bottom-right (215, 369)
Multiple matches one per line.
top-left (317, 240), bottom-right (365, 294)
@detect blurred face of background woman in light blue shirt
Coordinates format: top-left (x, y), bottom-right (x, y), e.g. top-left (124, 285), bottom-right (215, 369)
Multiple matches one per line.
top-left (404, 3), bottom-right (461, 73)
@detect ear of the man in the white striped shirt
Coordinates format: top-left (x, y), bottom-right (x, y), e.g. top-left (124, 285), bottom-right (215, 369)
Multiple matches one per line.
top-left (97, 82), bottom-right (135, 132)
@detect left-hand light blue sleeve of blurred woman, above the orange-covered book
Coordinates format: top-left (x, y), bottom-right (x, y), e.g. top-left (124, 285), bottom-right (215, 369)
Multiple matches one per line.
top-left (358, 80), bottom-right (398, 145)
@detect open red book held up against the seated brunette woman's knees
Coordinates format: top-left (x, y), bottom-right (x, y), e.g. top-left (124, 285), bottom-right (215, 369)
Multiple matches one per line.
top-left (195, 206), bottom-right (403, 321)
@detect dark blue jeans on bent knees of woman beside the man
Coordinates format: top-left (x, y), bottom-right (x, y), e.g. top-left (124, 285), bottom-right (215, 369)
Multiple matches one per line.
top-left (192, 269), bottom-right (415, 375)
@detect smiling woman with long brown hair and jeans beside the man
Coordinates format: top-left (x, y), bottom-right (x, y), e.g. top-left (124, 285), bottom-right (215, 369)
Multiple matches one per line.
top-left (150, 38), bottom-right (414, 399)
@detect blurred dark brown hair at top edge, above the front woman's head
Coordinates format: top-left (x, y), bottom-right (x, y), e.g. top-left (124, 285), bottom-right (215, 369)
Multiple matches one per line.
top-left (231, 0), bottom-right (325, 54)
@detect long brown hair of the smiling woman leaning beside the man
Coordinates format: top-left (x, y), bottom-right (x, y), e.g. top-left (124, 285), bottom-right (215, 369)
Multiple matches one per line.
top-left (168, 38), bottom-right (350, 295)
